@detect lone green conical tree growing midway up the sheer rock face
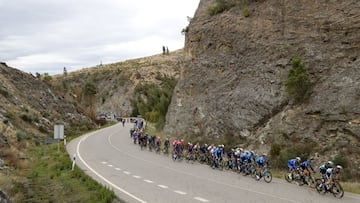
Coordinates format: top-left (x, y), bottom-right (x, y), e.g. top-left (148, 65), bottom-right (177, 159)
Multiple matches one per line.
top-left (285, 58), bottom-right (311, 103)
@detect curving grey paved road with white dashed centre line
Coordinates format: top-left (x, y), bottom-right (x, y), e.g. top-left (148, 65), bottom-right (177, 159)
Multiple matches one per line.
top-left (67, 124), bottom-right (360, 203)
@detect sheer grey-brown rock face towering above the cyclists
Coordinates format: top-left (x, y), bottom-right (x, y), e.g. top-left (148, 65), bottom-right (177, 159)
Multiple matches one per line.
top-left (165, 0), bottom-right (360, 160)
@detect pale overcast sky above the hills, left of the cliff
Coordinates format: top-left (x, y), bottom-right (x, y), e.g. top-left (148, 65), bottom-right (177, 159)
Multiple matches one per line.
top-left (0, 0), bottom-right (199, 74)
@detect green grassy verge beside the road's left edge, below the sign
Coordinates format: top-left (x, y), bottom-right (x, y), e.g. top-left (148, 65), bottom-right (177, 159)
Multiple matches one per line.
top-left (0, 122), bottom-right (124, 203)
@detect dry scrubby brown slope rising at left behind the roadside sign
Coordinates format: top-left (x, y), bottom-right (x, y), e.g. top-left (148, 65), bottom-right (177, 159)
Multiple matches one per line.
top-left (0, 63), bottom-right (95, 202)
